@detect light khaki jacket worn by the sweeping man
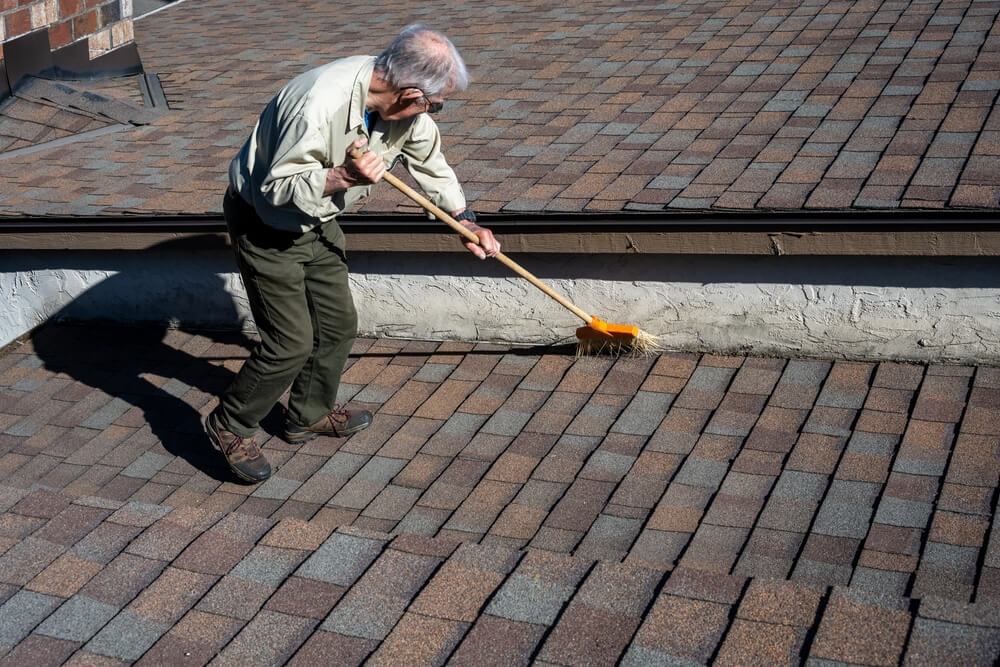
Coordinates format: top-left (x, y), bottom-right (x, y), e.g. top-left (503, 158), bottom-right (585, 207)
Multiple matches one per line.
top-left (229, 56), bottom-right (465, 237)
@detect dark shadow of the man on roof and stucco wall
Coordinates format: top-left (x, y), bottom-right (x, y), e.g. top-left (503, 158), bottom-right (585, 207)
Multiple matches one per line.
top-left (32, 236), bottom-right (281, 482)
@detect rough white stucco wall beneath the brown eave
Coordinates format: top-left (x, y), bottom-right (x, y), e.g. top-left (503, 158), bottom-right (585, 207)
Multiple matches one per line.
top-left (0, 247), bottom-right (1000, 363)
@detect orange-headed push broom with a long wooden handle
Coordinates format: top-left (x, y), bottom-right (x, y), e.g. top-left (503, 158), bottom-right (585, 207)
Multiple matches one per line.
top-left (354, 152), bottom-right (659, 355)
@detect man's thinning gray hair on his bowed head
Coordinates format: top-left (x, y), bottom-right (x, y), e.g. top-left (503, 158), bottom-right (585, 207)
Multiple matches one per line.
top-left (375, 24), bottom-right (469, 95)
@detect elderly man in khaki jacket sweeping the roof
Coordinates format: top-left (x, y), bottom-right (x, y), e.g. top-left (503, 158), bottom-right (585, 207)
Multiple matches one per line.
top-left (205, 25), bottom-right (500, 482)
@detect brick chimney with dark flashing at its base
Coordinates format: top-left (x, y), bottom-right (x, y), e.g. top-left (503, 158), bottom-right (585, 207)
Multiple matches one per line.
top-left (0, 0), bottom-right (142, 99)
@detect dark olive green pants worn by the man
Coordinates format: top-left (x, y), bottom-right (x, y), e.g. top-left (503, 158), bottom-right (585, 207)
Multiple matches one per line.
top-left (219, 190), bottom-right (358, 438)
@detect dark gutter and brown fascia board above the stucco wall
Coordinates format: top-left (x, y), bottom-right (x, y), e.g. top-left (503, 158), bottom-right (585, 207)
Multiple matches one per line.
top-left (0, 211), bottom-right (1000, 257)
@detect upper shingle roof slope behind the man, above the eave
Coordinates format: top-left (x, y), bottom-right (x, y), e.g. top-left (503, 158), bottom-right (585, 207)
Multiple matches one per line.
top-left (0, 0), bottom-right (1000, 216)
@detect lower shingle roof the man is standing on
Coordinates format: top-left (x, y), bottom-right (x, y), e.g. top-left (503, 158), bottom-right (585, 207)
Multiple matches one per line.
top-left (0, 325), bottom-right (1000, 665)
